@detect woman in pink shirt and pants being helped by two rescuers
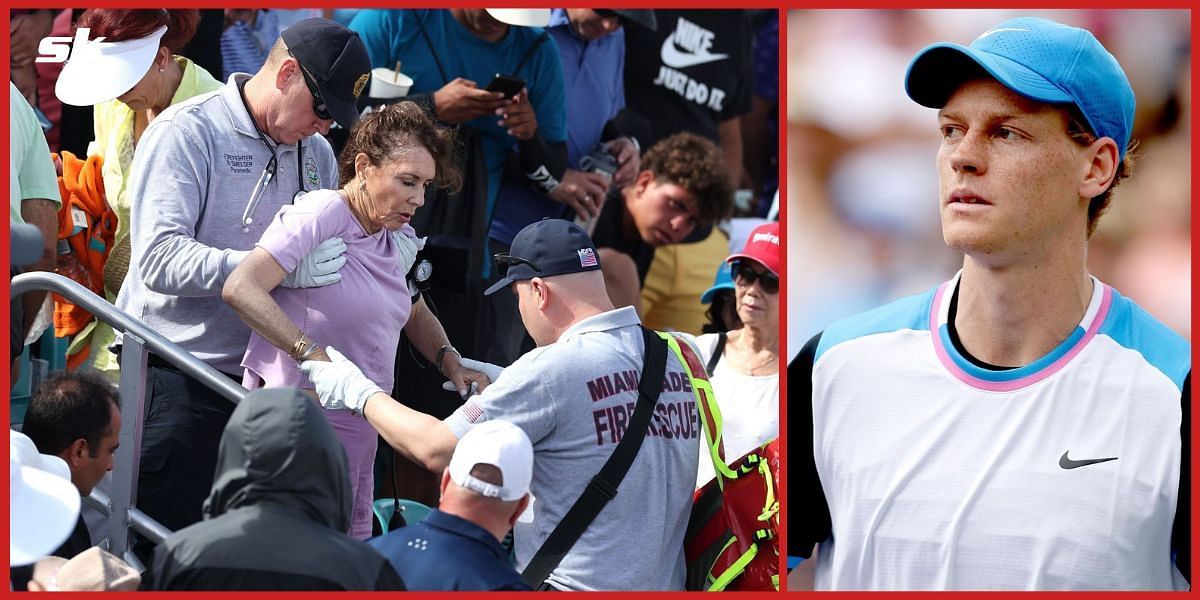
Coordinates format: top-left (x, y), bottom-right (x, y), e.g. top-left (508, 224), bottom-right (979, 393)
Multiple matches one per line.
top-left (222, 102), bottom-right (488, 539)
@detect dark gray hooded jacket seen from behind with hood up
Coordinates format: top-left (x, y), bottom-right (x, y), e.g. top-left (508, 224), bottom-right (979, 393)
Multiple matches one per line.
top-left (142, 389), bottom-right (404, 590)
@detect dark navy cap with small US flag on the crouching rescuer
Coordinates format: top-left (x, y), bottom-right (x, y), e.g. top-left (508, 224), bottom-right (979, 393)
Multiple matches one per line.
top-left (484, 218), bottom-right (600, 295)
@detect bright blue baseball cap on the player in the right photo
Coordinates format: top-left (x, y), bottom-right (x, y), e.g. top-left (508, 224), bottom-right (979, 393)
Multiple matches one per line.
top-left (905, 17), bottom-right (1134, 160)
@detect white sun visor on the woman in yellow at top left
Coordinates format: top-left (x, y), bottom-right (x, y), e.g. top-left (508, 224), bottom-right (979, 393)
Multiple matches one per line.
top-left (54, 25), bottom-right (167, 107)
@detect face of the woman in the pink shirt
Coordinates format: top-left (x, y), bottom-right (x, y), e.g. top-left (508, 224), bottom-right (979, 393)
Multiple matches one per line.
top-left (364, 145), bottom-right (437, 232)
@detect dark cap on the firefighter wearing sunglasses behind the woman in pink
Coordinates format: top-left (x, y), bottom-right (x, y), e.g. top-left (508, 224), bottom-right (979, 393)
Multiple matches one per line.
top-left (280, 17), bottom-right (371, 130)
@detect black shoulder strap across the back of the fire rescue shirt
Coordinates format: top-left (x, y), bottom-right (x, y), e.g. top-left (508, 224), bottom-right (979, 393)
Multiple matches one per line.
top-left (521, 326), bottom-right (667, 589)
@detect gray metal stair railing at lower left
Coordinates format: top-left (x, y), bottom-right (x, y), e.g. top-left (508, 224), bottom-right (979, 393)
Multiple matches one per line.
top-left (8, 271), bottom-right (246, 566)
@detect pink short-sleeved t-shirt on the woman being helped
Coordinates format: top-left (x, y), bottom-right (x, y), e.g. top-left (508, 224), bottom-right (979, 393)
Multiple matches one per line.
top-left (241, 190), bottom-right (415, 391)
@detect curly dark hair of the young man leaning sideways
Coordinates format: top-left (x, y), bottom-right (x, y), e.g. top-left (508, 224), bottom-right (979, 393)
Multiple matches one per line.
top-left (642, 132), bottom-right (733, 223)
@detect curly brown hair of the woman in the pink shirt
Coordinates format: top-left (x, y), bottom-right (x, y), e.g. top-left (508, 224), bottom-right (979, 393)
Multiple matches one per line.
top-left (337, 101), bottom-right (462, 192)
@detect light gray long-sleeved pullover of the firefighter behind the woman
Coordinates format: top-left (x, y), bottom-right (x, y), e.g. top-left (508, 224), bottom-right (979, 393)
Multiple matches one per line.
top-left (116, 73), bottom-right (337, 376)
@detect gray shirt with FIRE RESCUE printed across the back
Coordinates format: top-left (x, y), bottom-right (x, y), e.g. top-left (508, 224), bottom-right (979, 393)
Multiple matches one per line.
top-left (445, 307), bottom-right (700, 590)
